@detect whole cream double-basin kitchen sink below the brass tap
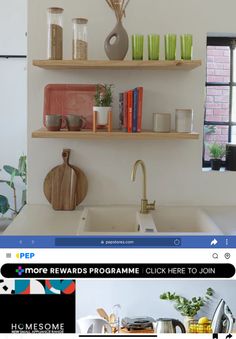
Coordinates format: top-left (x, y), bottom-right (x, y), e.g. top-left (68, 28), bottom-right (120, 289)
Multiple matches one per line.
top-left (77, 206), bottom-right (223, 235)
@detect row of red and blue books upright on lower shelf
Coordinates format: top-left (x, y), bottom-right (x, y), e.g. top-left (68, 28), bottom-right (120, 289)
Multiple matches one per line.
top-left (119, 87), bottom-right (143, 133)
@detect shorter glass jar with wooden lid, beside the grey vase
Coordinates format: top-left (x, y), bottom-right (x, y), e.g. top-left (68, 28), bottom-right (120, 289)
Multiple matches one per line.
top-left (72, 18), bottom-right (88, 60)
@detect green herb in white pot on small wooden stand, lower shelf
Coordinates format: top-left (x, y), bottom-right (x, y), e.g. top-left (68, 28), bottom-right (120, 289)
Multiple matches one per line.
top-left (93, 84), bottom-right (113, 126)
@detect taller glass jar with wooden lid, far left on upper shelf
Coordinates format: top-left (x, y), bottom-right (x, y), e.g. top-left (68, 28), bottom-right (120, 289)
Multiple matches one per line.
top-left (48, 7), bottom-right (64, 60)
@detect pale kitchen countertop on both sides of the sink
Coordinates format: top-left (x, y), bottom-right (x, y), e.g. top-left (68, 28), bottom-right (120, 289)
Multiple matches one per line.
top-left (3, 205), bottom-right (236, 236)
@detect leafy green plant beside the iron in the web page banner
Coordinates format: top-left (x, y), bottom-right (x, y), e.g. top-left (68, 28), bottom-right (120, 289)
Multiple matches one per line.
top-left (160, 288), bottom-right (214, 331)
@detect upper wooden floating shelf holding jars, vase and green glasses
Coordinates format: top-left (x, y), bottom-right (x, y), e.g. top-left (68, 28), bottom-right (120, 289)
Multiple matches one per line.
top-left (33, 60), bottom-right (202, 70)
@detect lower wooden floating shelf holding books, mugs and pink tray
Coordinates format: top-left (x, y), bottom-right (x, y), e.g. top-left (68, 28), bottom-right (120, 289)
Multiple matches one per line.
top-left (32, 128), bottom-right (199, 140)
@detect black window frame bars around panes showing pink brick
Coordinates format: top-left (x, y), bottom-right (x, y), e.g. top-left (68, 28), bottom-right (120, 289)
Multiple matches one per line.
top-left (202, 36), bottom-right (236, 168)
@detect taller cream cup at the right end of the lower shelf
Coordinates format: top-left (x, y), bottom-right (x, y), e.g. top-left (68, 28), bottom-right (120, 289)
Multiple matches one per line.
top-left (175, 109), bottom-right (193, 133)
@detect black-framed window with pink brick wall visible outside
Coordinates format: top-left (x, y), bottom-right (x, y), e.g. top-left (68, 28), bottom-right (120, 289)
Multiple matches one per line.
top-left (203, 37), bottom-right (236, 167)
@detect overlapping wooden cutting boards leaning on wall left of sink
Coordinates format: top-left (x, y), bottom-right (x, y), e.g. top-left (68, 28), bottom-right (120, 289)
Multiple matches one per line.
top-left (43, 149), bottom-right (88, 211)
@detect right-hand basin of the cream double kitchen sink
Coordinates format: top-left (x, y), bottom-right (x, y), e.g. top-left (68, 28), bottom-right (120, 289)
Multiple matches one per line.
top-left (152, 206), bottom-right (223, 235)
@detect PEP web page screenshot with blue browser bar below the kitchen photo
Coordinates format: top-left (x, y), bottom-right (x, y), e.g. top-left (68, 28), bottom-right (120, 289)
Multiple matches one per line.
top-left (0, 237), bottom-right (236, 338)
